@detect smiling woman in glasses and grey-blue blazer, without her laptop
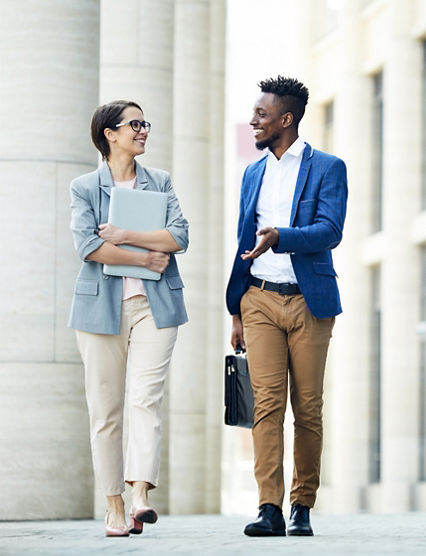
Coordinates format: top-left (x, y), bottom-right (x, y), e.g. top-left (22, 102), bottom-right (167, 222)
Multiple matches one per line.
top-left (69, 101), bottom-right (188, 536)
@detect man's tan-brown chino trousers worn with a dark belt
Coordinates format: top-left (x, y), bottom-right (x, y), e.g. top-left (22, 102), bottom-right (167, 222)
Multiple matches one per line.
top-left (241, 286), bottom-right (335, 508)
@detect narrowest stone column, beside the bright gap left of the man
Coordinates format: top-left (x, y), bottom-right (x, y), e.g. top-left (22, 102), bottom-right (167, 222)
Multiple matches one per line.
top-left (205, 0), bottom-right (226, 513)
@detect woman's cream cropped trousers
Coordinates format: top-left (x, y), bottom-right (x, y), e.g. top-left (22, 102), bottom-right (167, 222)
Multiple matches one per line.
top-left (76, 295), bottom-right (177, 496)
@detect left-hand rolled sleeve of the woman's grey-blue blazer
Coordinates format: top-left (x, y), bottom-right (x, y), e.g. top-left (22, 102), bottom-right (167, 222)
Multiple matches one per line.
top-left (70, 179), bottom-right (104, 261)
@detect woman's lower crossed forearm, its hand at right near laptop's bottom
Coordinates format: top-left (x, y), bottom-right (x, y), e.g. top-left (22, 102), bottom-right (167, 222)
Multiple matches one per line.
top-left (86, 241), bottom-right (170, 273)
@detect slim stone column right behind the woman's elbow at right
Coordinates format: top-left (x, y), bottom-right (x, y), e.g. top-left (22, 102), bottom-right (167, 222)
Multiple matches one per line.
top-left (170, 0), bottom-right (211, 513)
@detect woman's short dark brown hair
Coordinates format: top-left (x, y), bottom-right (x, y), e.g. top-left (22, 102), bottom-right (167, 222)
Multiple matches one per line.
top-left (90, 100), bottom-right (142, 160)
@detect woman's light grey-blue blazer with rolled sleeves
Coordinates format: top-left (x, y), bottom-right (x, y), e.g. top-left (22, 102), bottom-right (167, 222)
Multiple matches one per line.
top-left (68, 162), bottom-right (188, 334)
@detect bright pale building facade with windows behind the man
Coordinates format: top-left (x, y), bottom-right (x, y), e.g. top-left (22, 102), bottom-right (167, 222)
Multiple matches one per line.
top-left (224, 0), bottom-right (426, 513)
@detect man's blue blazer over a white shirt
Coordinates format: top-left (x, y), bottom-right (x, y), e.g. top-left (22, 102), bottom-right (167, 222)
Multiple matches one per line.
top-left (226, 143), bottom-right (348, 319)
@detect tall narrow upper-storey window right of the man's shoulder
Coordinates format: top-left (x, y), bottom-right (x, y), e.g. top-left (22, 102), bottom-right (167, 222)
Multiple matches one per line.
top-left (371, 72), bottom-right (383, 232)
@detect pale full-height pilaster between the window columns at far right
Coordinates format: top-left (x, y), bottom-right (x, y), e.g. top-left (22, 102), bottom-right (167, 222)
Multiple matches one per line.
top-left (381, 0), bottom-right (421, 512)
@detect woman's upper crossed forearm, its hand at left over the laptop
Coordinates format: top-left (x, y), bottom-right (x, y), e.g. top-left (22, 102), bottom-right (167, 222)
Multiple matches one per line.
top-left (99, 224), bottom-right (182, 253)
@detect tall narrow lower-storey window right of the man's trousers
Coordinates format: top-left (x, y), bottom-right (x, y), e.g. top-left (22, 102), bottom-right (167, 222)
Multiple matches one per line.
top-left (369, 266), bottom-right (382, 483)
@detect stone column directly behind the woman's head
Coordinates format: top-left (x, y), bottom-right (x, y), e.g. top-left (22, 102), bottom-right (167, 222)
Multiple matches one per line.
top-left (96, 0), bottom-right (174, 516)
